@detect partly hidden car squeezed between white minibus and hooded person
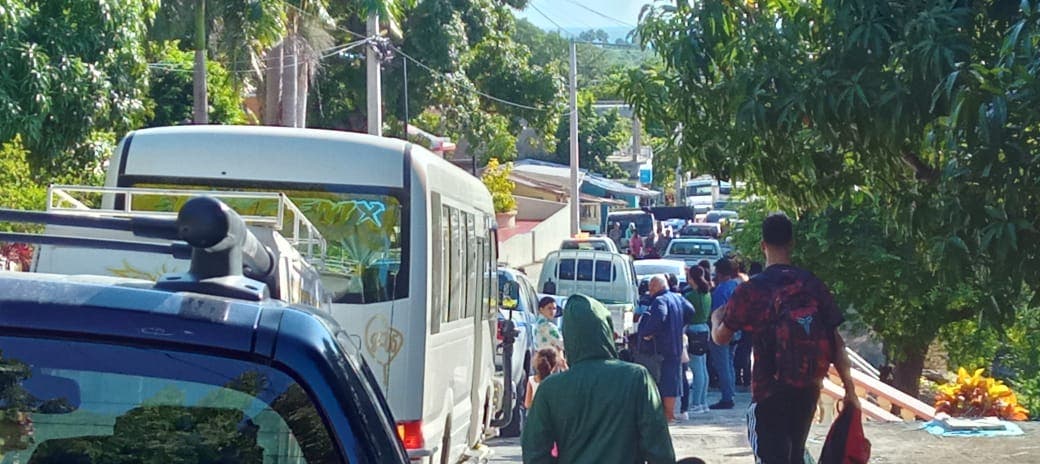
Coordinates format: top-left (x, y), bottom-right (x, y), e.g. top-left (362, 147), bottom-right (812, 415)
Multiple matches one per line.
top-left (495, 266), bottom-right (539, 437)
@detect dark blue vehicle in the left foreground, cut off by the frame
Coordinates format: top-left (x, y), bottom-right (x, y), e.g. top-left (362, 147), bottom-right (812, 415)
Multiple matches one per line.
top-left (0, 198), bottom-right (409, 464)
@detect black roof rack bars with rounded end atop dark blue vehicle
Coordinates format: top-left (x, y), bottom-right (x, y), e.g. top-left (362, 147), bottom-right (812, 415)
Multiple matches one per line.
top-left (0, 197), bottom-right (277, 301)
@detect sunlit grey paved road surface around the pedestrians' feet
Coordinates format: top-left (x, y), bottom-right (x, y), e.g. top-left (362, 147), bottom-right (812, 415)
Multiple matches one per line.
top-left (489, 392), bottom-right (1040, 464)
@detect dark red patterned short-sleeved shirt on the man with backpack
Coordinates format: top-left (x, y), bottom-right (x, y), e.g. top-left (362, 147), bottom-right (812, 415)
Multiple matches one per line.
top-left (723, 264), bottom-right (844, 403)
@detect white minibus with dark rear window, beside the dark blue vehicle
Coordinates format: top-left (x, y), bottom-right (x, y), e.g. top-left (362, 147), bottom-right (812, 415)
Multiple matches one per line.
top-left (100, 126), bottom-right (498, 463)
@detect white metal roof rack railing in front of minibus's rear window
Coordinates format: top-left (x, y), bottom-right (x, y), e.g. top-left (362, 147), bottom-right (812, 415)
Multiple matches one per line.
top-left (47, 185), bottom-right (328, 266)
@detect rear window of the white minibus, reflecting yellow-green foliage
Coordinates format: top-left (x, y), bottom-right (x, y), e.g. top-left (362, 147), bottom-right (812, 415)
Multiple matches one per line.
top-left (133, 183), bottom-right (408, 303)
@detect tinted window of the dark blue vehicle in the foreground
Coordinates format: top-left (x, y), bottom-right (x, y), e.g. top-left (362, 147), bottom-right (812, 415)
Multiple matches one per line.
top-left (0, 337), bottom-right (336, 464)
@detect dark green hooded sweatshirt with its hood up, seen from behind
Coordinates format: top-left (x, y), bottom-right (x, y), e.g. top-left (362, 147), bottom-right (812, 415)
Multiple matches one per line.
top-left (521, 294), bottom-right (675, 464)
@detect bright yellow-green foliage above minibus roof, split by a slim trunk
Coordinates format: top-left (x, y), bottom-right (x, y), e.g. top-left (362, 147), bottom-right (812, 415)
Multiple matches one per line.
top-left (145, 42), bottom-right (246, 127)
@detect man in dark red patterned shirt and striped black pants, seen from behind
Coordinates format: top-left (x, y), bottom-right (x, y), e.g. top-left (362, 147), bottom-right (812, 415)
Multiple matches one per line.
top-left (711, 213), bottom-right (859, 464)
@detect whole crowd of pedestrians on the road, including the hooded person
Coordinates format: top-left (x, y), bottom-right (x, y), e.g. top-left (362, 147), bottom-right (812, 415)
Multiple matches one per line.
top-left (522, 214), bottom-right (859, 464)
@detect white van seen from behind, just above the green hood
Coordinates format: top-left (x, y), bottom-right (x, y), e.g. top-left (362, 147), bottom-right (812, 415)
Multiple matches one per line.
top-left (538, 250), bottom-right (639, 341)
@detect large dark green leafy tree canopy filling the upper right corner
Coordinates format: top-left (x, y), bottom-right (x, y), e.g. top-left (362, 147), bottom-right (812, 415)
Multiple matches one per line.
top-left (625, 0), bottom-right (1040, 393)
